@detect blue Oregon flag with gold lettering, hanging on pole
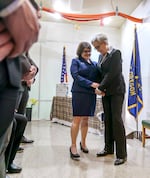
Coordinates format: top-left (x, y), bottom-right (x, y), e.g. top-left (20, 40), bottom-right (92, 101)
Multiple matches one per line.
top-left (128, 28), bottom-right (143, 118)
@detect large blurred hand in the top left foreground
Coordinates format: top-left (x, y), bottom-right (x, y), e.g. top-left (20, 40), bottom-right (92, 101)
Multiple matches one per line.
top-left (3, 0), bottom-right (40, 57)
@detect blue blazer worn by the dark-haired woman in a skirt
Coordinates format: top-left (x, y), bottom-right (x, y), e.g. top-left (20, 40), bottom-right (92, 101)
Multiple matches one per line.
top-left (70, 57), bottom-right (100, 94)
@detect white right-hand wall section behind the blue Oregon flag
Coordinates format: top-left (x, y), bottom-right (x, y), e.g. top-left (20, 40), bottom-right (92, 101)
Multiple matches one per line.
top-left (121, 0), bottom-right (150, 130)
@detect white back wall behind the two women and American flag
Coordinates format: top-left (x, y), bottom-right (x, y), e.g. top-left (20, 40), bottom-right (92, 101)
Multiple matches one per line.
top-left (30, 22), bottom-right (120, 119)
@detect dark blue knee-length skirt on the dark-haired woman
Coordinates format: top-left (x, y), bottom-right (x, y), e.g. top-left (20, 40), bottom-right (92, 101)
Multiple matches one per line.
top-left (72, 92), bottom-right (96, 116)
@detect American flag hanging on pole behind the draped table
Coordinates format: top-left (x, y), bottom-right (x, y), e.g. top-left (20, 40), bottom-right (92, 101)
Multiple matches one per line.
top-left (60, 46), bottom-right (68, 83)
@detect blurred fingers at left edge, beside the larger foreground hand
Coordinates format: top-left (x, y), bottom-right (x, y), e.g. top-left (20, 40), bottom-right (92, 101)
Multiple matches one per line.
top-left (0, 21), bottom-right (14, 61)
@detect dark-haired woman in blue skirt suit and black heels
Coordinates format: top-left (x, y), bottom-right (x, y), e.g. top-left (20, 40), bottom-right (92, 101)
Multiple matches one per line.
top-left (70, 42), bottom-right (99, 159)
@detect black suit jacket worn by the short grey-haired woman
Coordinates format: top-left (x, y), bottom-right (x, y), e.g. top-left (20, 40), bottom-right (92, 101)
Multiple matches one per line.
top-left (99, 49), bottom-right (125, 95)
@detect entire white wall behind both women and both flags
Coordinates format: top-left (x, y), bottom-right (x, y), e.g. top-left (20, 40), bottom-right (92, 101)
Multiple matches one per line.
top-left (27, 0), bottom-right (150, 134)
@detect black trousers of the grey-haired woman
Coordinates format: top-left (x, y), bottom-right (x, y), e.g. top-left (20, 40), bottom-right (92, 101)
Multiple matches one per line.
top-left (102, 94), bottom-right (127, 158)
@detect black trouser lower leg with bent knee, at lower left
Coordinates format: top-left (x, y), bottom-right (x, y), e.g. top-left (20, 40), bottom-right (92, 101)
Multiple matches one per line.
top-left (5, 113), bottom-right (27, 168)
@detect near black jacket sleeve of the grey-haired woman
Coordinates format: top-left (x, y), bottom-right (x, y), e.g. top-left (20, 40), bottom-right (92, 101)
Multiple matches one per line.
top-left (99, 50), bottom-right (122, 91)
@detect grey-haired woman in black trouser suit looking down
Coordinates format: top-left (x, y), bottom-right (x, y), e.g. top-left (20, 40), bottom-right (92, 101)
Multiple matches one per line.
top-left (92, 34), bottom-right (127, 165)
